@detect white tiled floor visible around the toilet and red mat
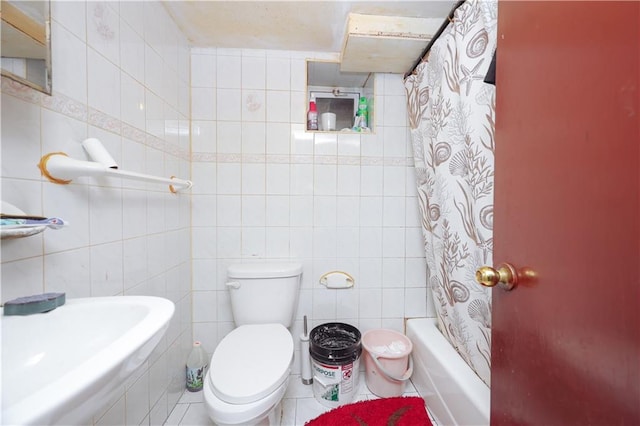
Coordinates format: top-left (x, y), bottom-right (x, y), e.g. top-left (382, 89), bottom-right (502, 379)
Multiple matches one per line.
top-left (165, 372), bottom-right (437, 426)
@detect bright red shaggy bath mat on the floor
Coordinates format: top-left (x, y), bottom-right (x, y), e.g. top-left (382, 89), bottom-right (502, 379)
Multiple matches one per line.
top-left (305, 396), bottom-right (431, 426)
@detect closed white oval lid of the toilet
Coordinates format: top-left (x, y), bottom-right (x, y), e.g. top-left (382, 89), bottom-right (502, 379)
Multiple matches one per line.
top-left (208, 324), bottom-right (293, 404)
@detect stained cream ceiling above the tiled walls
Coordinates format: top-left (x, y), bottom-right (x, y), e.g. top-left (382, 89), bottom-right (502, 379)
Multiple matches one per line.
top-left (163, 0), bottom-right (456, 52)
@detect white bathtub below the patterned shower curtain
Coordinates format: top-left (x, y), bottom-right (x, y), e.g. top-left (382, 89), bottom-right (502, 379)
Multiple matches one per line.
top-left (407, 318), bottom-right (490, 426)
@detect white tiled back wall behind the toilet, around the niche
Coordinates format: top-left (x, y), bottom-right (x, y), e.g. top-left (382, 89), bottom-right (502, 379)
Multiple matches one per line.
top-left (191, 49), bottom-right (427, 370)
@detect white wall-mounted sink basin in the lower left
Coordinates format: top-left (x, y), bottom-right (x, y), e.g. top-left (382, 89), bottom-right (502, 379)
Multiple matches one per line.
top-left (0, 296), bottom-right (174, 425)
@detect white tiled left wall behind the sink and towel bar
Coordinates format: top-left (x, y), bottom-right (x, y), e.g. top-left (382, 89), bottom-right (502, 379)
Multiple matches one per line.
top-left (1, 1), bottom-right (194, 425)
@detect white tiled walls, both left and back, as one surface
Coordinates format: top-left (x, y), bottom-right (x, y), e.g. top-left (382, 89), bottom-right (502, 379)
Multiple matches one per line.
top-left (1, 5), bottom-right (428, 425)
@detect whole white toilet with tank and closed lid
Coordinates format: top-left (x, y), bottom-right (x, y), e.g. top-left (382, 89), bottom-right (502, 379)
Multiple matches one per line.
top-left (204, 263), bottom-right (302, 426)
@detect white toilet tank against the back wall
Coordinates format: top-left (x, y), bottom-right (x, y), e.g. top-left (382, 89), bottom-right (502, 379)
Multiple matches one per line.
top-left (227, 263), bottom-right (302, 328)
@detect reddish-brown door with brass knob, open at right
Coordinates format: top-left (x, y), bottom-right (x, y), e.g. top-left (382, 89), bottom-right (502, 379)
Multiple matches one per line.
top-left (491, 1), bottom-right (640, 425)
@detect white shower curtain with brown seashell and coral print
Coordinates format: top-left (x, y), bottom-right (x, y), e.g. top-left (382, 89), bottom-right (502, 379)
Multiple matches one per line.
top-left (405, 0), bottom-right (497, 385)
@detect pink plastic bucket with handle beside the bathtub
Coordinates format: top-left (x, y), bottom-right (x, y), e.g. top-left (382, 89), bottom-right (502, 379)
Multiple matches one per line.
top-left (362, 329), bottom-right (413, 398)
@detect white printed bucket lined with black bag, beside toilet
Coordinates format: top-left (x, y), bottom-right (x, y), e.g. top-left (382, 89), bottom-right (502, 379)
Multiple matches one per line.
top-left (309, 322), bottom-right (362, 408)
